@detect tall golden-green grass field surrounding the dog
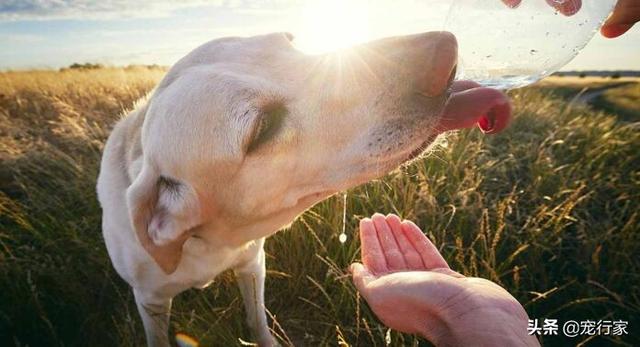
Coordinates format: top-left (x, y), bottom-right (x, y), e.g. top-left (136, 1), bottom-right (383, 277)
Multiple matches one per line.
top-left (0, 68), bottom-right (640, 346)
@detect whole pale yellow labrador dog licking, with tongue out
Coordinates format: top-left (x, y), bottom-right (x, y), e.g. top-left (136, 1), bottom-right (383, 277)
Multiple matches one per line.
top-left (97, 32), bottom-right (511, 346)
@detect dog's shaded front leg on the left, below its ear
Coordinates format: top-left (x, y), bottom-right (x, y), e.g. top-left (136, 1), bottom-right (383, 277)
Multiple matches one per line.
top-left (133, 289), bottom-right (171, 347)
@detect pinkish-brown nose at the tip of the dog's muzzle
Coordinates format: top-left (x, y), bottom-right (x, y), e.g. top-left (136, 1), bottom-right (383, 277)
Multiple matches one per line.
top-left (415, 31), bottom-right (458, 96)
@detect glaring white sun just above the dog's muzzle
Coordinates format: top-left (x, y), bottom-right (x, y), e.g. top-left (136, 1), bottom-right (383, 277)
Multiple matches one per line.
top-left (296, 0), bottom-right (371, 54)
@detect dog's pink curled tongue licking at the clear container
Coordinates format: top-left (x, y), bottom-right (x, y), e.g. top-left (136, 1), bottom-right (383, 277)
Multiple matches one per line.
top-left (438, 81), bottom-right (511, 134)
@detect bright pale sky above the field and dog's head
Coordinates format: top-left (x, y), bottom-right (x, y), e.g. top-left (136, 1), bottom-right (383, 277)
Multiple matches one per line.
top-left (0, 0), bottom-right (640, 70)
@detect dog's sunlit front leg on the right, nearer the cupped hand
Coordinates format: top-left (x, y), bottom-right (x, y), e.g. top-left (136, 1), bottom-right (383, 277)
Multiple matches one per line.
top-left (234, 239), bottom-right (277, 347)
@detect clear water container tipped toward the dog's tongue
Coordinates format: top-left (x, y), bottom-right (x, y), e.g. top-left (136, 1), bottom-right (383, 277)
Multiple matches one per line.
top-left (444, 0), bottom-right (616, 89)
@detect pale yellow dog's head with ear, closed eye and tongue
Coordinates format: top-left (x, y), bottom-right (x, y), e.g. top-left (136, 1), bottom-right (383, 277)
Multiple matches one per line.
top-left (127, 32), bottom-right (510, 273)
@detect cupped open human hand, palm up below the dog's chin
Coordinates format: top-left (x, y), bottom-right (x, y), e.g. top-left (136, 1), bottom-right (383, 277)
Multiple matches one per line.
top-left (351, 214), bottom-right (538, 346)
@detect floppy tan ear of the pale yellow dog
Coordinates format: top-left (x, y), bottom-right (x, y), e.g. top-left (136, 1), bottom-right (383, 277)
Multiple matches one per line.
top-left (127, 164), bottom-right (200, 274)
